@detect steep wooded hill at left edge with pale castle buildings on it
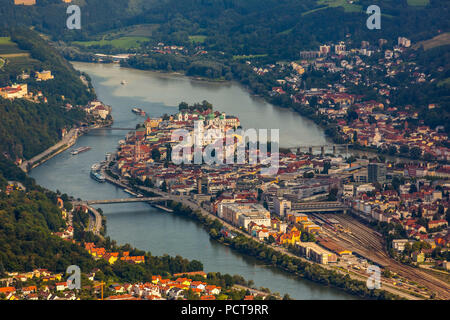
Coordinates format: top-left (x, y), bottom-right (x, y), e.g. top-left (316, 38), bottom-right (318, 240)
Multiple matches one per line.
top-left (0, 29), bottom-right (95, 161)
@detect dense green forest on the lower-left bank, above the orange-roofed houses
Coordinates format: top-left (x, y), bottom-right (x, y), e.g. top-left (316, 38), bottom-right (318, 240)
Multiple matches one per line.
top-left (0, 155), bottom-right (253, 288)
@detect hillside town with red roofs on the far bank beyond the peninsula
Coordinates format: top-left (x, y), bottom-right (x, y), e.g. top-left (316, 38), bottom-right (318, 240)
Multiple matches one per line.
top-left (120, 36), bottom-right (450, 161)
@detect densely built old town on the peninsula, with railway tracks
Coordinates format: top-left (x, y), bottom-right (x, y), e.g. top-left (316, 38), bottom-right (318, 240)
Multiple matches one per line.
top-left (99, 101), bottom-right (450, 296)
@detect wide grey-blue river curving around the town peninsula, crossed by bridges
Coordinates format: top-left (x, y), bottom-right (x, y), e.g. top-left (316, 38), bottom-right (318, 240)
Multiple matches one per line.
top-left (31, 63), bottom-right (354, 299)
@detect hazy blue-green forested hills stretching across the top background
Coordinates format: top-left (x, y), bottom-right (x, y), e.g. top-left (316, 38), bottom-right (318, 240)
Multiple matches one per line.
top-left (0, 0), bottom-right (450, 59)
